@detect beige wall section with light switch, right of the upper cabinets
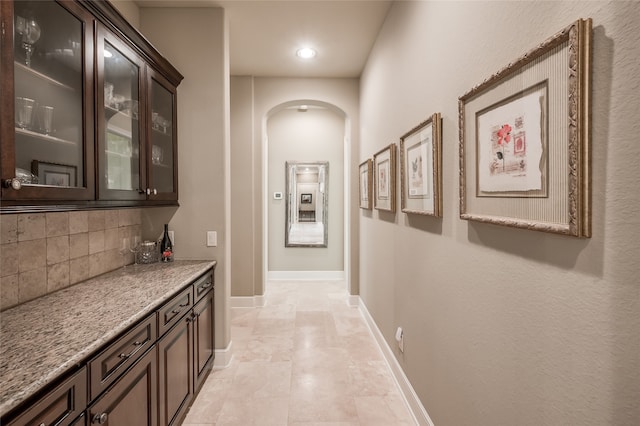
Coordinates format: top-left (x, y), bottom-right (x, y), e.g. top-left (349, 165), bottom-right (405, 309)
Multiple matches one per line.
top-left (140, 8), bottom-right (230, 349)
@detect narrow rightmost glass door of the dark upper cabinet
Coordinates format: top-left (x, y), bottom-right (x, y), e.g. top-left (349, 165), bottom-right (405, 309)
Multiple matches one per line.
top-left (147, 70), bottom-right (178, 200)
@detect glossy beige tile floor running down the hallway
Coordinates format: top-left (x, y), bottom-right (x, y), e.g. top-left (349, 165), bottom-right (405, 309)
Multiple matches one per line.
top-left (183, 281), bottom-right (416, 426)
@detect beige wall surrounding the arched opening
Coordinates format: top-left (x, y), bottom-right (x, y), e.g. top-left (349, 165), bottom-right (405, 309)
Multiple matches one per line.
top-left (231, 76), bottom-right (360, 296)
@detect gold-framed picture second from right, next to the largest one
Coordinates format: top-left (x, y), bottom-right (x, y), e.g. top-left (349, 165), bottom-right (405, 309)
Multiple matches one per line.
top-left (400, 113), bottom-right (442, 217)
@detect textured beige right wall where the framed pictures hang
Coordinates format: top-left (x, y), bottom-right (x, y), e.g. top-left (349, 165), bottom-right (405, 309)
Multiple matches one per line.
top-left (354, 1), bottom-right (640, 426)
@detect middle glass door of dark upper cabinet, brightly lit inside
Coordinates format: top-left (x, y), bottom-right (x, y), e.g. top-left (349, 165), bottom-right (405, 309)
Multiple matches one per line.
top-left (97, 26), bottom-right (147, 200)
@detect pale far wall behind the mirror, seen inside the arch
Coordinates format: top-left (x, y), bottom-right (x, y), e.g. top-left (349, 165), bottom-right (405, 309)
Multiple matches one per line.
top-left (266, 108), bottom-right (345, 271)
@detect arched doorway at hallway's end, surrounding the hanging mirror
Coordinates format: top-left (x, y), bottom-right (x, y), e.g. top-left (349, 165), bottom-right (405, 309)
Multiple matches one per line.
top-left (262, 99), bottom-right (350, 285)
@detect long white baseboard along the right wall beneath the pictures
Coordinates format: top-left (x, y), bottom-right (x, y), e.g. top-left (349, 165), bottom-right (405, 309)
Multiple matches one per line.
top-left (357, 297), bottom-right (434, 426)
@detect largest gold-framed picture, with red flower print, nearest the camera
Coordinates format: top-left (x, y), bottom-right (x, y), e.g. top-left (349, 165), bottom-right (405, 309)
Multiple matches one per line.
top-left (458, 19), bottom-right (592, 237)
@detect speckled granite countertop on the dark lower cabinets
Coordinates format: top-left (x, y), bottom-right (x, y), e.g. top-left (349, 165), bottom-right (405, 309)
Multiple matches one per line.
top-left (0, 261), bottom-right (216, 416)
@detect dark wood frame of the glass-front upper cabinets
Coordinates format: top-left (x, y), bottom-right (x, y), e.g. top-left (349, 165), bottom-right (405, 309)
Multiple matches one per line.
top-left (0, 0), bottom-right (183, 213)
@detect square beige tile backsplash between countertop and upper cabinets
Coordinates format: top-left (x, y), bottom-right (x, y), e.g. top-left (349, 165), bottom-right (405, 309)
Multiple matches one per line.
top-left (0, 209), bottom-right (142, 310)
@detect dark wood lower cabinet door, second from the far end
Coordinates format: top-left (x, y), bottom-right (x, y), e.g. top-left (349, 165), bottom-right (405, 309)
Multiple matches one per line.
top-left (158, 313), bottom-right (193, 426)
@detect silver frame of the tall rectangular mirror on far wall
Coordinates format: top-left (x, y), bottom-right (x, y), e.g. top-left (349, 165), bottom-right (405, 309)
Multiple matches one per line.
top-left (284, 161), bottom-right (329, 248)
